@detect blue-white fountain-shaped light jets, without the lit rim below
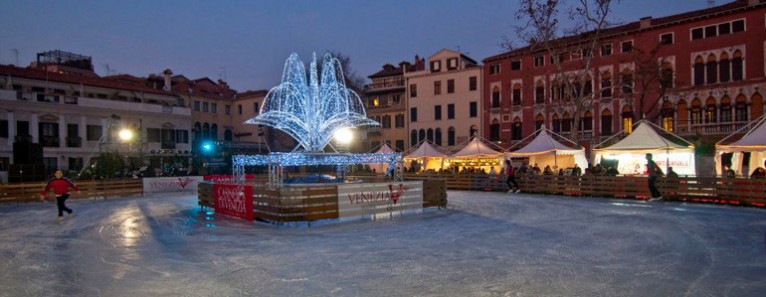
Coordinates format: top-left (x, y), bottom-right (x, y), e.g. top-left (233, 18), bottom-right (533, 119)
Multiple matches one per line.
top-left (245, 53), bottom-right (380, 152)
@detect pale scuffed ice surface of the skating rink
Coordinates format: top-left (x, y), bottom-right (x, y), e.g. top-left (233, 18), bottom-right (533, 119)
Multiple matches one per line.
top-left (0, 191), bottom-right (766, 297)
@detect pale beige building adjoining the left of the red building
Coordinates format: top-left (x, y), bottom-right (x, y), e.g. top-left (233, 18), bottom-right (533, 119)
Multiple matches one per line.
top-left (404, 49), bottom-right (484, 148)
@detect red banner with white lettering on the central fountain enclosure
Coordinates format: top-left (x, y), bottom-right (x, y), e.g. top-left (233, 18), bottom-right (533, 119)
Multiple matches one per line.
top-left (213, 183), bottom-right (255, 221)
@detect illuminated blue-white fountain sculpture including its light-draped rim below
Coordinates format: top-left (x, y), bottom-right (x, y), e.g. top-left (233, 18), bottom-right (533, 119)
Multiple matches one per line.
top-left (232, 53), bottom-right (402, 185)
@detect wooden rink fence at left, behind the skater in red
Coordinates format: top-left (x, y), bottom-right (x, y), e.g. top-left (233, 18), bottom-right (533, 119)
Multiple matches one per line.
top-left (0, 179), bottom-right (144, 203)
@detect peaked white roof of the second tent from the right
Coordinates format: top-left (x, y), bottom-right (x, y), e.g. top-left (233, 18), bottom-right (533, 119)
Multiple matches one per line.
top-left (594, 121), bottom-right (693, 151)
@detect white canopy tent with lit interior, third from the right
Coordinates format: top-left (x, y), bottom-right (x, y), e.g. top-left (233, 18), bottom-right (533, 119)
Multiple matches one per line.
top-left (510, 128), bottom-right (588, 169)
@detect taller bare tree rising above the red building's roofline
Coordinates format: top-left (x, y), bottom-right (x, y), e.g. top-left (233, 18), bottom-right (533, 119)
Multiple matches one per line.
top-left (516, 0), bottom-right (612, 142)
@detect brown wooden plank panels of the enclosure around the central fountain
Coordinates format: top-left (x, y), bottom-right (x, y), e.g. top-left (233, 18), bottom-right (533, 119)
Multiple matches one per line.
top-left (198, 177), bottom-right (447, 223)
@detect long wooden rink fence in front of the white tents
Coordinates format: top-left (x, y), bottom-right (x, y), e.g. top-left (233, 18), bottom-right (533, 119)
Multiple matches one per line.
top-left (405, 173), bottom-right (766, 207)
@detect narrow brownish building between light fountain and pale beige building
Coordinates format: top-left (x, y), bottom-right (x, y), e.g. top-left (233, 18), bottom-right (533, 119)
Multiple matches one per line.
top-left (364, 56), bottom-right (425, 151)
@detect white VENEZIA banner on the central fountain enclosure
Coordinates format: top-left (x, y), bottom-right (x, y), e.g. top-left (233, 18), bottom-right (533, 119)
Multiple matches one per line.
top-left (338, 181), bottom-right (423, 220)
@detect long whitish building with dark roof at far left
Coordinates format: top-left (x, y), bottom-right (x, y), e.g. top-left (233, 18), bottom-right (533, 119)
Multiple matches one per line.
top-left (0, 52), bottom-right (192, 180)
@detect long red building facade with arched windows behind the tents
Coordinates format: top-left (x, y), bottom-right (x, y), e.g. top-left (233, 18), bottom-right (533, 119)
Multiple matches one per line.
top-left (482, 0), bottom-right (766, 151)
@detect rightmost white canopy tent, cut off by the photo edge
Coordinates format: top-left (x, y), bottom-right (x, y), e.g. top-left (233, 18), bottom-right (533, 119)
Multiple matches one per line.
top-left (715, 115), bottom-right (766, 176)
